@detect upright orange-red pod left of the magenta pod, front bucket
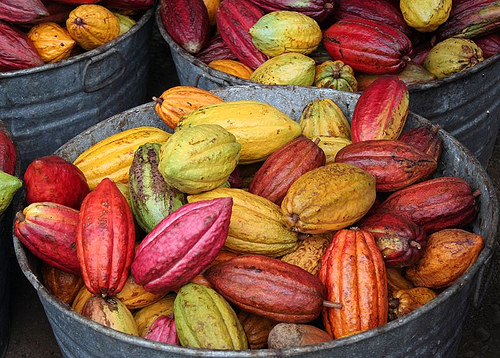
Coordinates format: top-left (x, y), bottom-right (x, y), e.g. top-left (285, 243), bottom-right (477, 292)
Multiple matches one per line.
top-left (76, 178), bottom-right (135, 296)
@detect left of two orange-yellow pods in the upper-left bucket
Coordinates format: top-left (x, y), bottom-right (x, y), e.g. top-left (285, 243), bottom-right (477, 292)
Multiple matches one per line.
top-left (28, 22), bottom-right (76, 63)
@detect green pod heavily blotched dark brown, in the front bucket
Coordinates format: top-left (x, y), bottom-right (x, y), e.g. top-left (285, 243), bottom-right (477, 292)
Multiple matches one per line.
top-left (129, 143), bottom-right (186, 233)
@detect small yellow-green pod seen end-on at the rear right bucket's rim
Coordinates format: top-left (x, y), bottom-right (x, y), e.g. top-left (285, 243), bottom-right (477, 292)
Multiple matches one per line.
top-left (314, 61), bottom-right (358, 92)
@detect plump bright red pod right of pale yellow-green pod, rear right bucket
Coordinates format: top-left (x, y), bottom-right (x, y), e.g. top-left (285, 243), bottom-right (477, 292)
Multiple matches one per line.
top-left (323, 19), bottom-right (412, 74)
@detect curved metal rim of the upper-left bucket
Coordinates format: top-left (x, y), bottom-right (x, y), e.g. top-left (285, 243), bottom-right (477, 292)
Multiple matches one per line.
top-left (0, 6), bottom-right (154, 80)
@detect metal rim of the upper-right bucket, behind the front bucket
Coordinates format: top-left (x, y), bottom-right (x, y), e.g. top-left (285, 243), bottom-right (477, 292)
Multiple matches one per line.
top-left (156, 5), bottom-right (500, 93)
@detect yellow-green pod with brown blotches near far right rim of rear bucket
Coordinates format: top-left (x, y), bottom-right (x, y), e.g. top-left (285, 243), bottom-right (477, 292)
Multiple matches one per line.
top-left (424, 38), bottom-right (482, 78)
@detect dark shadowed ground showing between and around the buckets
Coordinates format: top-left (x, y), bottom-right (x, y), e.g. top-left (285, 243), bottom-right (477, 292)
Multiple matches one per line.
top-left (2, 25), bottom-right (500, 358)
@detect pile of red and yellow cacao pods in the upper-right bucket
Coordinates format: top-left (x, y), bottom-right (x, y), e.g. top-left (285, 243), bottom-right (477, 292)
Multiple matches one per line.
top-left (160, 0), bottom-right (500, 92)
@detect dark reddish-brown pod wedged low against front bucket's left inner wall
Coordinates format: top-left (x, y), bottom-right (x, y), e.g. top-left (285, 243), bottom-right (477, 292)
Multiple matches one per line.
top-left (42, 261), bottom-right (83, 305)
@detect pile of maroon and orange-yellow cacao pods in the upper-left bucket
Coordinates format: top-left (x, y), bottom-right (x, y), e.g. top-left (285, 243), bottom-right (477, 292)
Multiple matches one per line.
top-left (0, 0), bottom-right (154, 72)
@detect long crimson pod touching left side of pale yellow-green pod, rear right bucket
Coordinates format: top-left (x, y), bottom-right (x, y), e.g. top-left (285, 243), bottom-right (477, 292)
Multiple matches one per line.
top-left (215, 0), bottom-right (268, 69)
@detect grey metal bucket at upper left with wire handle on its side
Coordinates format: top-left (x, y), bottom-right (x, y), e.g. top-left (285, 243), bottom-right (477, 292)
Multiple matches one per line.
top-left (0, 8), bottom-right (154, 171)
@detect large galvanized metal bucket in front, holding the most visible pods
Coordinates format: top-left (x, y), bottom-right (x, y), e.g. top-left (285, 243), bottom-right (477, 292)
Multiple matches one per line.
top-left (14, 86), bottom-right (499, 358)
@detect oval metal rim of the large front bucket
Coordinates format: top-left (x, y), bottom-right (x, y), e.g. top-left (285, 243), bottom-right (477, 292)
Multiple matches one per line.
top-left (9, 84), bottom-right (499, 358)
